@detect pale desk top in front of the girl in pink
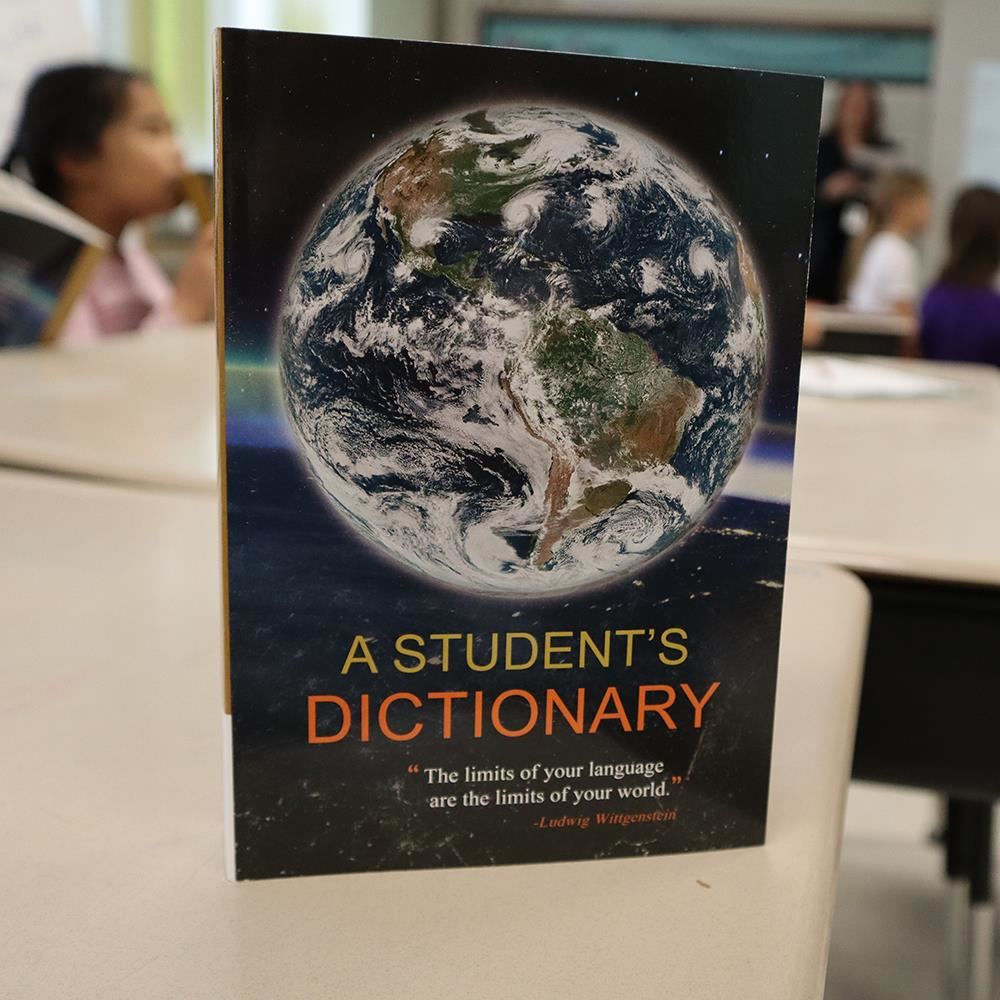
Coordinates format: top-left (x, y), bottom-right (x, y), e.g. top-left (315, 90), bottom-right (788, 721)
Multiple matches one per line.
top-left (0, 326), bottom-right (218, 490)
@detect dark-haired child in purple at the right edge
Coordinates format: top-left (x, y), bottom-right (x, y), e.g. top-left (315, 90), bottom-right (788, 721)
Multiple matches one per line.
top-left (920, 187), bottom-right (1000, 365)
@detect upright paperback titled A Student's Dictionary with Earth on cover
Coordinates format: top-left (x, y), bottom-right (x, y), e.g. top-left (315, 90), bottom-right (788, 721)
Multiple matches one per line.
top-left (216, 29), bottom-right (821, 879)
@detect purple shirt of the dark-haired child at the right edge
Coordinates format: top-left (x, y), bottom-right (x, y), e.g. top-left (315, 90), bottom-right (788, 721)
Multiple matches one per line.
top-left (920, 285), bottom-right (1000, 365)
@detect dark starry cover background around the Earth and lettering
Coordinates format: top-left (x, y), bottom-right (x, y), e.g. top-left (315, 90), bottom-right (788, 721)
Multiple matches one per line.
top-left (221, 31), bottom-right (821, 878)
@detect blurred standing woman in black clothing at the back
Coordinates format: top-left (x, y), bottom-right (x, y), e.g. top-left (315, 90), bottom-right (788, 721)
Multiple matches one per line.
top-left (809, 80), bottom-right (892, 303)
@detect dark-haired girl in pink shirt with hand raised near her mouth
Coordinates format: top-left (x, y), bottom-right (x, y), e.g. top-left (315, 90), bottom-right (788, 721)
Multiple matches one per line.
top-left (4, 64), bottom-right (214, 342)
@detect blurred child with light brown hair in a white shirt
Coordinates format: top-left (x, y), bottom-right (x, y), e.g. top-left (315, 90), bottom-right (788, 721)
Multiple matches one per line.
top-left (844, 170), bottom-right (931, 317)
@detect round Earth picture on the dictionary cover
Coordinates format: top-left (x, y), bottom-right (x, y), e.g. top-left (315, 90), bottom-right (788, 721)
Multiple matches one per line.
top-left (277, 105), bottom-right (766, 595)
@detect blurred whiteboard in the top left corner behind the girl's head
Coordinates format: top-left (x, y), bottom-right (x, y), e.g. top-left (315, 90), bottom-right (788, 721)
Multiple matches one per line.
top-left (0, 0), bottom-right (97, 160)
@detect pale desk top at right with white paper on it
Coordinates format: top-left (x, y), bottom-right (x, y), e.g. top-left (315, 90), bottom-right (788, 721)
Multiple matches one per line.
top-left (789, 358), bottom-right (1000, 585)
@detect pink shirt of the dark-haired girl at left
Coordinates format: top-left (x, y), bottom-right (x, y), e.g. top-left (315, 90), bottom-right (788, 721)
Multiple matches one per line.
top-left (59, 240), bottom-right (179, 344)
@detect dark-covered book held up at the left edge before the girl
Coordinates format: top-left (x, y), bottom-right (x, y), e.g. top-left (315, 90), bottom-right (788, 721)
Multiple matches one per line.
top-left (0, 171), bottom-right (109, 347)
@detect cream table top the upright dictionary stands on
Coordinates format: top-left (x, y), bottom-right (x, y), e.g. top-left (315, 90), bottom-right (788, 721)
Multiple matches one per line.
top-left (0, 471), bottom-right (868, 1000)
